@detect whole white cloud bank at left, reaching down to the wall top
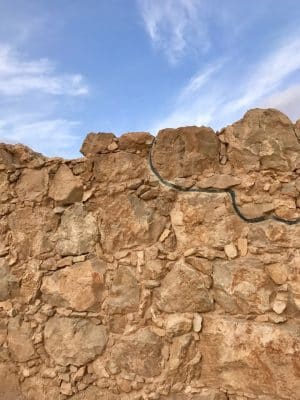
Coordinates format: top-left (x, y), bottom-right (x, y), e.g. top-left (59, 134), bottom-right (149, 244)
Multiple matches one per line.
top-left (0, 44), bottom-right (89, 158)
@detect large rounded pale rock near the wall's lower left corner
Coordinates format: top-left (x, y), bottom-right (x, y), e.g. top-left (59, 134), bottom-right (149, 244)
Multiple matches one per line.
top-left (44, 316), bottom-right (107, 366)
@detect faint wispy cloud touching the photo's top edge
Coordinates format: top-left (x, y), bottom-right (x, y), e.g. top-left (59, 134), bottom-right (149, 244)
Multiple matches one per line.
top-left (138, 0), bottom-right (209, 63)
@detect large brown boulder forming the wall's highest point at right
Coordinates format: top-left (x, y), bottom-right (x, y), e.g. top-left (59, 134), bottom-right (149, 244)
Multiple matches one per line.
top-left (223, 109), bottom-right (300, 171)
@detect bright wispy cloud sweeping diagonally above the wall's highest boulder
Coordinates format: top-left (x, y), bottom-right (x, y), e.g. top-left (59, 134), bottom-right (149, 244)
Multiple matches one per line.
top-left (151, 34), bottom-right (300, 133)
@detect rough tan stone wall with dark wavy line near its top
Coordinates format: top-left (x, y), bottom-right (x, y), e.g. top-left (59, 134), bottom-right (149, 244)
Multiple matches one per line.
top-left (0, 109), bottom-right (300, 400)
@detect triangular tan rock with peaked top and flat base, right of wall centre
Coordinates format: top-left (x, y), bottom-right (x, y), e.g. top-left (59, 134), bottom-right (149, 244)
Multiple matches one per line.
top-left (156, 262), bottom-right (214, 312)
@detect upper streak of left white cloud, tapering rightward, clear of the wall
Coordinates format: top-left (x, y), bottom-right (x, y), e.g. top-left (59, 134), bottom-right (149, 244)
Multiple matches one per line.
top-left (0, 44), bottom-right (88, 96)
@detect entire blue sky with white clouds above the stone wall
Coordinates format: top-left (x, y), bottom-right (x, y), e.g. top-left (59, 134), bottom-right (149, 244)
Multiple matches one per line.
top-left (0, 0), bottom-right (300, 158)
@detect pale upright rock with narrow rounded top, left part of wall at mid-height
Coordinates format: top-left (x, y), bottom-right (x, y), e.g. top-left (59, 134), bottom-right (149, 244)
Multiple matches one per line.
top-left (56, 204), bottom-right (98, 256)
